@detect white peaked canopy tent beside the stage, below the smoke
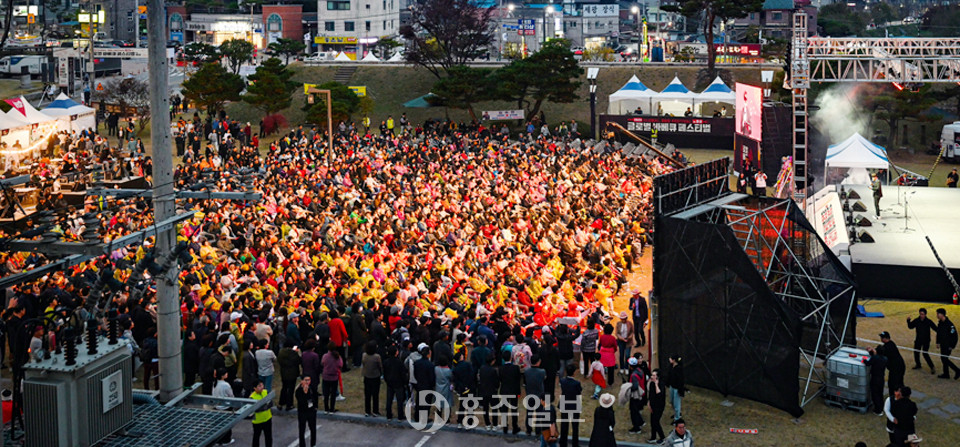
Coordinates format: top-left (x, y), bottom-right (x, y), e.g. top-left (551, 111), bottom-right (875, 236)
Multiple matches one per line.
top-left (824, 133), bottom-right (890, 185)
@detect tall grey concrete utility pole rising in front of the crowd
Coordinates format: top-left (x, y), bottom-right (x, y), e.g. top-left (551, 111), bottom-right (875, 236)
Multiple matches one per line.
top-left (146, 0), bottom-right (183, 402)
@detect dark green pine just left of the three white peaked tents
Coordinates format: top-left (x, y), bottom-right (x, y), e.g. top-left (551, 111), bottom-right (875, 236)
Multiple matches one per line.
top-left (492, 39), bottom-right (583, 121)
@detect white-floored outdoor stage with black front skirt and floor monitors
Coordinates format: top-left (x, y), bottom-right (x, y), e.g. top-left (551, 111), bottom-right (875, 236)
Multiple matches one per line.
top-left (845, 185), bottom-right (960, 302)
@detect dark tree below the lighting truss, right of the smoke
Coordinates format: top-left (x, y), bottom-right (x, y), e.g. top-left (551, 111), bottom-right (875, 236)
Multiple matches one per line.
top-left (871, 84), bottom-right (938, 146)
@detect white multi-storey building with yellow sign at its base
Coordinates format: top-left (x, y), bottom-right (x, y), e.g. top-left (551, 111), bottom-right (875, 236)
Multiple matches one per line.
top-left (314, 0), bottom-right (401, 59)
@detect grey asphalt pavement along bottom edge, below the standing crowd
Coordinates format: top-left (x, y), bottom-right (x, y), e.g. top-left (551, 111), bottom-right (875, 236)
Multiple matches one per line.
top-left (233, 414), bottom-right (539, 447)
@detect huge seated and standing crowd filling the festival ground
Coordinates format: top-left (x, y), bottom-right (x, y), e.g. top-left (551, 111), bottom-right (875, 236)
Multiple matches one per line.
top-left (2, 110), bottom-right (690, 445)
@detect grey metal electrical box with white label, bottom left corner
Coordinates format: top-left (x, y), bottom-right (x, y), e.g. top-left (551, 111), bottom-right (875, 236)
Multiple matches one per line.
top-left (23, 339), bottom-right (133, 447)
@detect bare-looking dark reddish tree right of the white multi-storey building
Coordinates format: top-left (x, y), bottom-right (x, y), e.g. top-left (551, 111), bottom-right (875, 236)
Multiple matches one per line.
top-left (400, 0), bottom-right (494, 78)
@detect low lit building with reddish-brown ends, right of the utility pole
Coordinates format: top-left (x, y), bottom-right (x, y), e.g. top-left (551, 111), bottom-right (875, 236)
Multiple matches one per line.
top-left (167, 4), bottom-right (303, 49)
